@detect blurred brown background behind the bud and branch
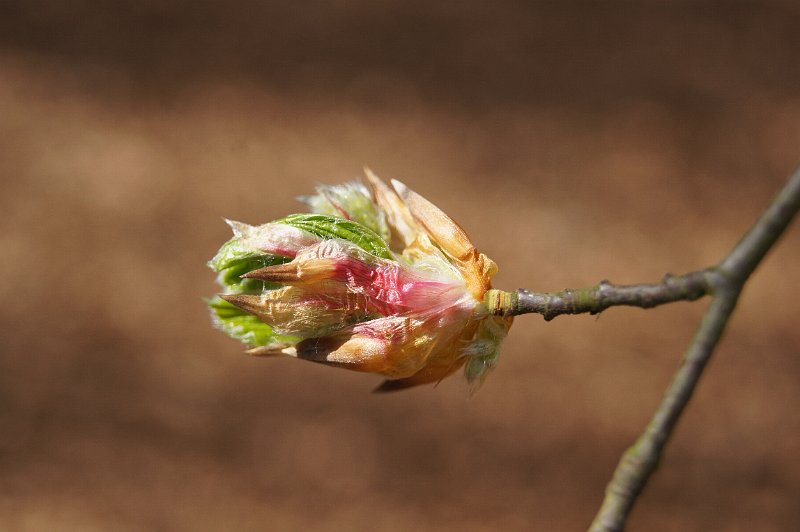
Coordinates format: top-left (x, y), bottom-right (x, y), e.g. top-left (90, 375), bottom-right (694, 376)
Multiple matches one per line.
top-left (0, 0), bottom-right (800, 531)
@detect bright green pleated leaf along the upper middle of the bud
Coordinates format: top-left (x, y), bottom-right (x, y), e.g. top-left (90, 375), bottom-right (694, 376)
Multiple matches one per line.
top-left (275, 214), bottom-right (394, 260)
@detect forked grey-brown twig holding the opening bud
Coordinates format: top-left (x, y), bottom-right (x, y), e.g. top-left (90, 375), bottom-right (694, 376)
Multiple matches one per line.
top-left (486, 164), bottom-right (800, 532)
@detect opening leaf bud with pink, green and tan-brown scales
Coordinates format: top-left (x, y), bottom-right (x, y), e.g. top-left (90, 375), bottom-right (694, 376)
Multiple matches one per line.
top-left (208, 170), bottom-right (512, 391)
